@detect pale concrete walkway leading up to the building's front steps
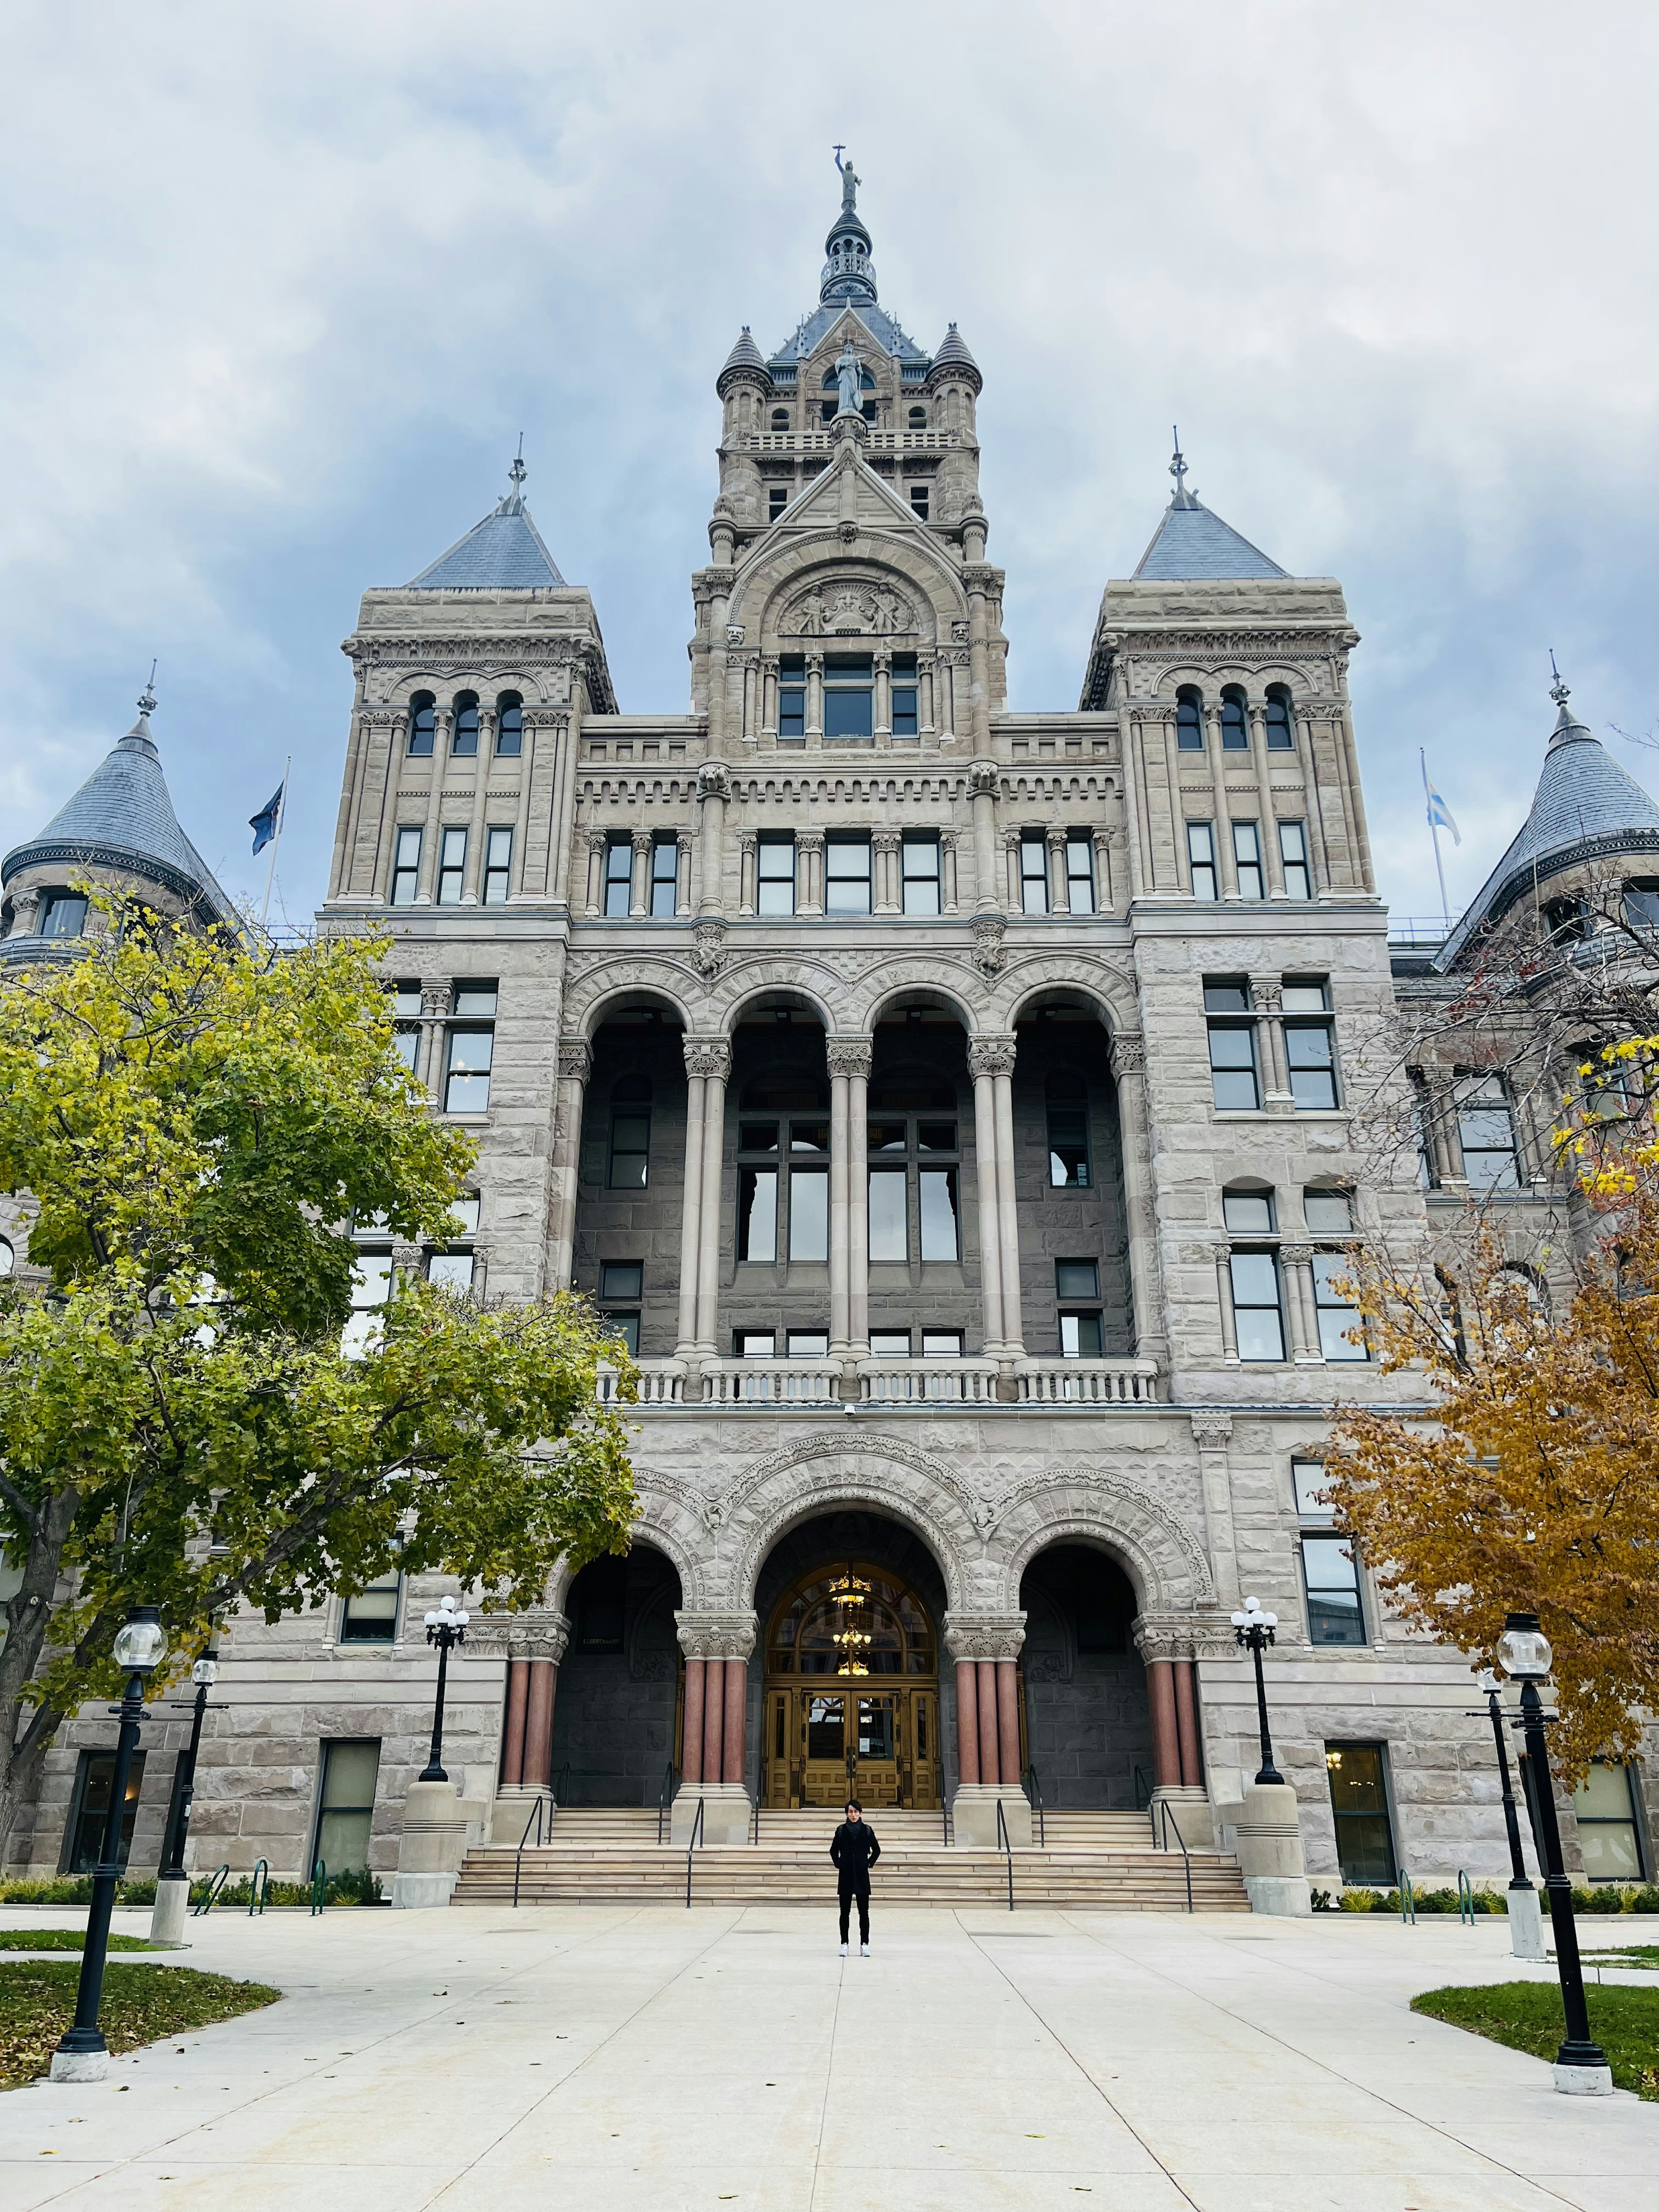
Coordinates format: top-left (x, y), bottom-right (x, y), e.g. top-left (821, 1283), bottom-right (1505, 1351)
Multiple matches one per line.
top-left (0, 1907), bottom-right (1659, 2212)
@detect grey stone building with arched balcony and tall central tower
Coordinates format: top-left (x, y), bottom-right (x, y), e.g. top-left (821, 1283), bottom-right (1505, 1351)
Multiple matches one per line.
top-left (6, 160), bottom-right (1655, 1887)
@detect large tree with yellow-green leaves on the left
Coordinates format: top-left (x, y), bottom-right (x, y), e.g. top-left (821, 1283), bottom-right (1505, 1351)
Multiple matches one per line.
top-left (0, 893), bottom-right (635, 1858)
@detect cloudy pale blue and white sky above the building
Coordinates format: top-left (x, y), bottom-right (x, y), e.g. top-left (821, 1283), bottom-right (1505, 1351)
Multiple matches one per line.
top-left (0, 0), bottom-right (1659, 920)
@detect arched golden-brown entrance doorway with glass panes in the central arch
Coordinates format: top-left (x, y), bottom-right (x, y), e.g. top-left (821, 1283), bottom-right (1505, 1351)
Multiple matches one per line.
top-left (761, 1557), bottom-right (940, 1809)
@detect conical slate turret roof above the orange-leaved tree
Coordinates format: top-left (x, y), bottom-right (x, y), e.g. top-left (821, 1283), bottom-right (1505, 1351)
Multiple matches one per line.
top-left (1436, 683), bottom-right (1659, 971)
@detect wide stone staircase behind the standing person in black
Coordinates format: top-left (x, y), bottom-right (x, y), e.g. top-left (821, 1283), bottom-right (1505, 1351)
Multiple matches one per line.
top-left (454, 1807), bottom-right (1250, 1913)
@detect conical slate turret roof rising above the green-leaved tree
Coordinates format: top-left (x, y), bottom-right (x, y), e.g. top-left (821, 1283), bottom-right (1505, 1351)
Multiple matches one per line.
top-left (0, 690), bottom-right (237, 933)
